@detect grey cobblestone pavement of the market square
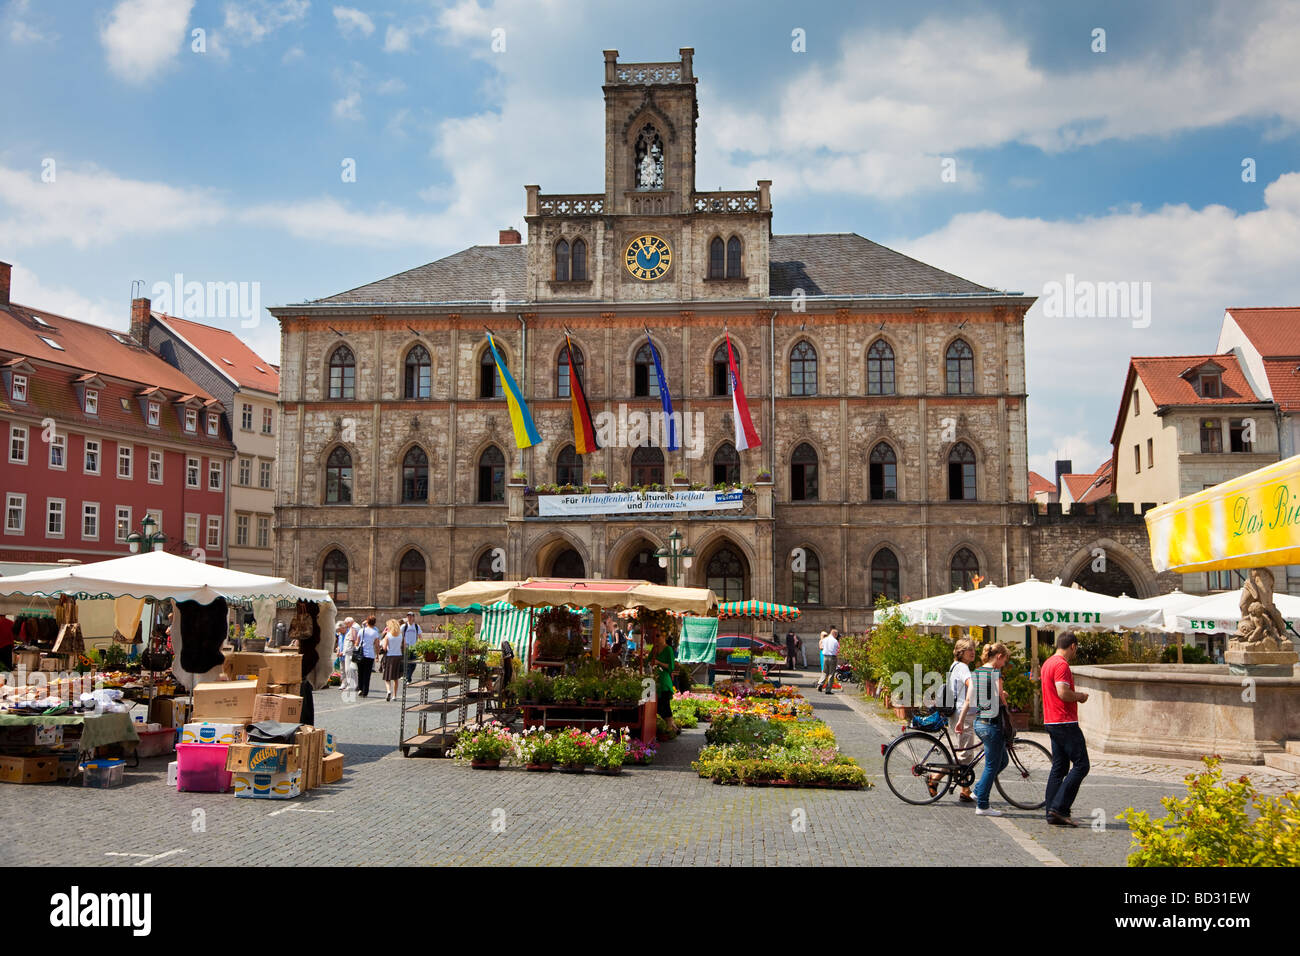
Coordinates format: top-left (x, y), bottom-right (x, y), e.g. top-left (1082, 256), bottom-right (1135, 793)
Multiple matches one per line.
top-left (0, 678), bottom-right (1289, 866)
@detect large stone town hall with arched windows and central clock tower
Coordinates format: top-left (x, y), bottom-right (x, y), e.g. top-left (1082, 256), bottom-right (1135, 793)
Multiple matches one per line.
top-left (270, 48), bottom-right (1034, 632)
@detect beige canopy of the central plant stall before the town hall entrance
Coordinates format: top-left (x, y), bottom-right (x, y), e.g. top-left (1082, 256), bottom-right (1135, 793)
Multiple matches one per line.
top-left (438, 578), bottom-right (718, 617)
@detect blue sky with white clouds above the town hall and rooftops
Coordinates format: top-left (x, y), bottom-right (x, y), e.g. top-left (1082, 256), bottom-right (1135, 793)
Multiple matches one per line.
top-left (0, 0), bottom-right (1300, 472)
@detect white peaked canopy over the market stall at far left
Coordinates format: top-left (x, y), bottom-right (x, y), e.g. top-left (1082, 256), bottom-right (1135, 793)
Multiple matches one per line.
top-left (0, 551), bottom-right (333, 604)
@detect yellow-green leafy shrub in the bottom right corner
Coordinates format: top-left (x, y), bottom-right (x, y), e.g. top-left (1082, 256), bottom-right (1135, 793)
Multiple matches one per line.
top-left (1118, 757), bottom-right (1300, 868)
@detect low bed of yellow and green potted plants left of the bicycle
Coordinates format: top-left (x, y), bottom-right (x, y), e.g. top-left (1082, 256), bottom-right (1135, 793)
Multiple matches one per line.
top-left (675, 683), bottom-right (870, 790)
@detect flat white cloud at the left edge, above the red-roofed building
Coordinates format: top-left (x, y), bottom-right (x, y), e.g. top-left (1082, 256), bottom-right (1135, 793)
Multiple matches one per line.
top-left (0, 164), bottom-right (225, 248)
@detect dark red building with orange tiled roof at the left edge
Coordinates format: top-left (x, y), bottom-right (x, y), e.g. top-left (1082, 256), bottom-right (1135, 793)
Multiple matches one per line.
top-left (0, 263), bottom-right (234, 564)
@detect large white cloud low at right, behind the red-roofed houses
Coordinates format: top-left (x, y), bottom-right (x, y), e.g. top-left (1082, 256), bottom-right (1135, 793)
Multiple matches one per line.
top-left (889, 172), bottom-right (1300, 470)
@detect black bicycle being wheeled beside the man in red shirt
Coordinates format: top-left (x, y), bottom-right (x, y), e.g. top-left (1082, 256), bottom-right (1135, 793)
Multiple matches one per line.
top-left (880, 717), bottom-right (1052, 810)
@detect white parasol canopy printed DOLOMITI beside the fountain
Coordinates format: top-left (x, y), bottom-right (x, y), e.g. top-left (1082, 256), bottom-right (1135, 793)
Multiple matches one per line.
top-left (896, 578), bottom-right (1162, 631)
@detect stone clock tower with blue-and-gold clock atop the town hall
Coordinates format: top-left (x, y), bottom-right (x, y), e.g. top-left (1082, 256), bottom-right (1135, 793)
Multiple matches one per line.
top-left (525, 47), bottom-right (772, 303)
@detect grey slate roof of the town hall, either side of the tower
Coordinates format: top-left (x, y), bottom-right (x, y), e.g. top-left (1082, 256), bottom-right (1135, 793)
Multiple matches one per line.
top-left (307, 233), bottom-right (997, 304)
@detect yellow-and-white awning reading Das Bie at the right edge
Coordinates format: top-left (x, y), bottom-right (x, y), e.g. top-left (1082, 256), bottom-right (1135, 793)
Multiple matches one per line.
top-left (1147, 455), bottom-right (1300, 574)
